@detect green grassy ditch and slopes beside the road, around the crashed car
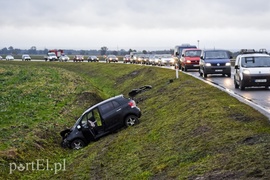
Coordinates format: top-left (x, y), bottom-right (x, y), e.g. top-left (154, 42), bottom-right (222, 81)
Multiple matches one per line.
top-left (0, 62), bottom-right (270, 179)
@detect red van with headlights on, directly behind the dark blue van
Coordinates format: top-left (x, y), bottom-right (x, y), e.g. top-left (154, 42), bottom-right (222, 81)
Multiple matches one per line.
top-left (180, 48), bottom-right (201, 71)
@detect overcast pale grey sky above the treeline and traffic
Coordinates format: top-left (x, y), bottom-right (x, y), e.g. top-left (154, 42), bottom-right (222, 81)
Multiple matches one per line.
top-left (0, 0), bottom-right (270, 50)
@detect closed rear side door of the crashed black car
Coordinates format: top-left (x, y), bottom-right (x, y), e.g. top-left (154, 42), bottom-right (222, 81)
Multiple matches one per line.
top-left (99, 100), bottom-right (123, 131)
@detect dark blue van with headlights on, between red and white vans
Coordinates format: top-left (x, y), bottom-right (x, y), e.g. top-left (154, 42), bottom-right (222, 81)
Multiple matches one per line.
top-left (199, 49), bottom-right (232, 78)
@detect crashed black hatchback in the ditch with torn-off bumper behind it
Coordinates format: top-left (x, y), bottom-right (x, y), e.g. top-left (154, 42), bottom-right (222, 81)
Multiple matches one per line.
top-left (60, 86), bottom-right (152, 149)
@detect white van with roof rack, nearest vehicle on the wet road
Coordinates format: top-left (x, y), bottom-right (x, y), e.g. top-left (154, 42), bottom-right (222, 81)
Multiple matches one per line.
top-left (234, 49), bottom-right (270, 90)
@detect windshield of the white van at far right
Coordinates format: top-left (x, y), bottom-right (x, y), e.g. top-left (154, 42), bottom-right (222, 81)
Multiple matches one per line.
top-left (241, 57), bottom-right (270, 67)
